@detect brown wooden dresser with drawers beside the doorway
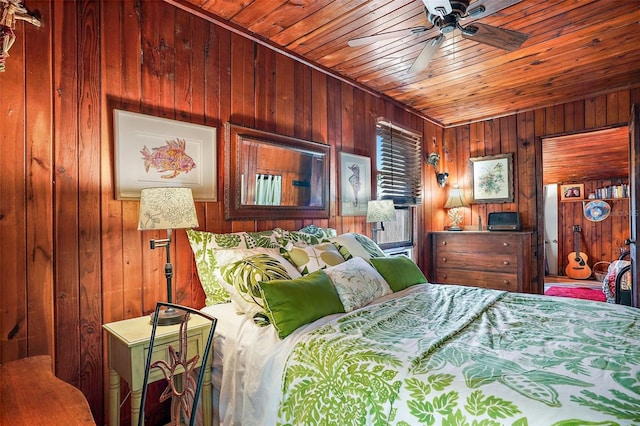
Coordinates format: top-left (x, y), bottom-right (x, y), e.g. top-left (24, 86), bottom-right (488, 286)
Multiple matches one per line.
top-left (430, 231), bottom-right (532, 292)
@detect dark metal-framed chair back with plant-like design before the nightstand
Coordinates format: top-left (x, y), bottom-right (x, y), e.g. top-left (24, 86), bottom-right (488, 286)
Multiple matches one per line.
top-left (138, 302), bottom-right (217, 426)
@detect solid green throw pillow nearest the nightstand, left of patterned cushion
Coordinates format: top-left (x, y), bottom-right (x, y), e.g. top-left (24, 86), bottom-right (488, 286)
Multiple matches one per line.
top-left (260, 270), bottom-right (344, 339)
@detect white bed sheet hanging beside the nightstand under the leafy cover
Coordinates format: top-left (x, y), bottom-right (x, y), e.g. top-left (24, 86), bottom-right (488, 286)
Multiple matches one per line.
top-left (202, 284), bottom-right (430, 426)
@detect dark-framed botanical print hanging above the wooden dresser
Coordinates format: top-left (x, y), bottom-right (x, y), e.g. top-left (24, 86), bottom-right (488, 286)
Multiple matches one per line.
top-left (469, 152), bottom-right (514, 203)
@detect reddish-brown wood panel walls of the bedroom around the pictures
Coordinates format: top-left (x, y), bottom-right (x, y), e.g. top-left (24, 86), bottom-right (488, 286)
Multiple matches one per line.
top-left (0, 0), bottom-right (640, 424)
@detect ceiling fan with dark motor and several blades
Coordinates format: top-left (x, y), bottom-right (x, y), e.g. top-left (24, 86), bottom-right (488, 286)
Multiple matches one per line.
top-left (347, 0), bottom-right (528, 73)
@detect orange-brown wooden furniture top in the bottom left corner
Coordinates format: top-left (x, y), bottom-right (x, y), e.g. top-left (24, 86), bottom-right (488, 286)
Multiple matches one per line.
top-left (0, 355), bottom-right (95, 426)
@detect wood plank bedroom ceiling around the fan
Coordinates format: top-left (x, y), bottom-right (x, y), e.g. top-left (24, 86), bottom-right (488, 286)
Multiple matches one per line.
top-left (172, 0), bottom-right (640, 127)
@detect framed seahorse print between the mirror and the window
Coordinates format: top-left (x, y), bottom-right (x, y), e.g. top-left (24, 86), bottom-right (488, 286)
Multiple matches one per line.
top-left (340, 152), bottom-right (371, 216)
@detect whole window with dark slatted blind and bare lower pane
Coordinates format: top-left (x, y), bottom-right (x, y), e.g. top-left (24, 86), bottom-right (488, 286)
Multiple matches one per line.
top-left (374, 120), bottom-right (422, 250)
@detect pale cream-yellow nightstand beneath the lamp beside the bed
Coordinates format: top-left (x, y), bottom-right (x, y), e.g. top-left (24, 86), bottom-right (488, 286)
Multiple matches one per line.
top-left (102, 315), bottom-right (213, 426)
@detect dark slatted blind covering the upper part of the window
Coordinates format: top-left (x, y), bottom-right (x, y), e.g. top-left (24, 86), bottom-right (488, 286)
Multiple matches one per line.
top-left (376, 120), bottom-right (422, 206)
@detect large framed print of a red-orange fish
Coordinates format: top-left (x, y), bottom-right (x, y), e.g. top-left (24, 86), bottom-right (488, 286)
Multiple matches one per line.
top-left (113, 109), bottom-right (218, 201)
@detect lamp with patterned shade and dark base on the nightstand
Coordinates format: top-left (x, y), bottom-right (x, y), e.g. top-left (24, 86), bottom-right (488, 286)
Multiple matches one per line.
top-left (138, 187), bottom-right (198, 325)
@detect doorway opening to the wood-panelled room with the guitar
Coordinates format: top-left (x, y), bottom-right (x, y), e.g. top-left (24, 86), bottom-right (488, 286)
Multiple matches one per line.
top-left (541, 126), bottom-right (630, 286)
